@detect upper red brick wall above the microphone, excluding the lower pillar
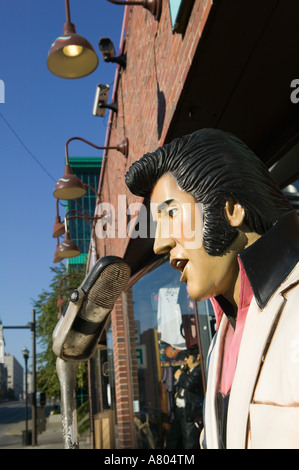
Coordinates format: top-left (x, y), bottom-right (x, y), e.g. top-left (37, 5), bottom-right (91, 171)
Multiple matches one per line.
top-left (97, 0), bottom-right (212, 256)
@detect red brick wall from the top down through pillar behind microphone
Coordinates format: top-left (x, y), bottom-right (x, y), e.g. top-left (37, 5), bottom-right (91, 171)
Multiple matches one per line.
top-left (97, 0), bottom-right (212, 449)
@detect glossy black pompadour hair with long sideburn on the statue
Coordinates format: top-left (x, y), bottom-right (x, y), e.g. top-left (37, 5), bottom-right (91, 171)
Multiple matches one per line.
top-left (126, 129), bottom-right (293, 256)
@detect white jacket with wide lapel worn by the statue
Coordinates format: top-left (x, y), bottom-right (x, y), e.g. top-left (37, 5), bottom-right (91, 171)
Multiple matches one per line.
top-left (204, 212), bottom-right (299, 449)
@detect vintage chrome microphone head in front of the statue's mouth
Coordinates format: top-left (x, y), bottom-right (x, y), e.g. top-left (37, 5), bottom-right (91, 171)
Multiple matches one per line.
top-left (53, 256), bottom-right (130, 361)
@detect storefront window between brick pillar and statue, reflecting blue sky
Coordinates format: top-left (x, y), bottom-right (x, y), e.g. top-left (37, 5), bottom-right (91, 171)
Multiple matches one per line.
top-left (132, 262), bottom-right (212, 449)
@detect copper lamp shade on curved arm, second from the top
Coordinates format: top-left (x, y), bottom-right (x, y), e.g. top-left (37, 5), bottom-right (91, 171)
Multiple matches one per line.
top-left (53, 164), bottom-right (86, 201)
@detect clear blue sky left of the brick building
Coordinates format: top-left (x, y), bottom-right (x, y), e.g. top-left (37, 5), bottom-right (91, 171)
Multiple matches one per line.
top-left (0, 0), bottom-right (124, 366)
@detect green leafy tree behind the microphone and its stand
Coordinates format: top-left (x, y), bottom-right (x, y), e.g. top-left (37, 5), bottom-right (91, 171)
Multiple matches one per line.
top-left (34, 264), bottom-right (87, 398)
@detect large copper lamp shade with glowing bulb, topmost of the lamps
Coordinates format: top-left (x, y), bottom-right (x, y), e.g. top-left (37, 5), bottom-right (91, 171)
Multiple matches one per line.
top-left (47, 1), bottom-right (99, 78)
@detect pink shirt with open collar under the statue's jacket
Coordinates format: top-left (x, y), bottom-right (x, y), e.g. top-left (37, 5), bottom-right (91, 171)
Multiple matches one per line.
top-left (211, 259), bottom-right (253, 396)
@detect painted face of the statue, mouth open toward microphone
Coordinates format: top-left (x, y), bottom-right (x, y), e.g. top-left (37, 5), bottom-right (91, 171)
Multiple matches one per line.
top-left (151, 174), bottom-right (238, 301)
